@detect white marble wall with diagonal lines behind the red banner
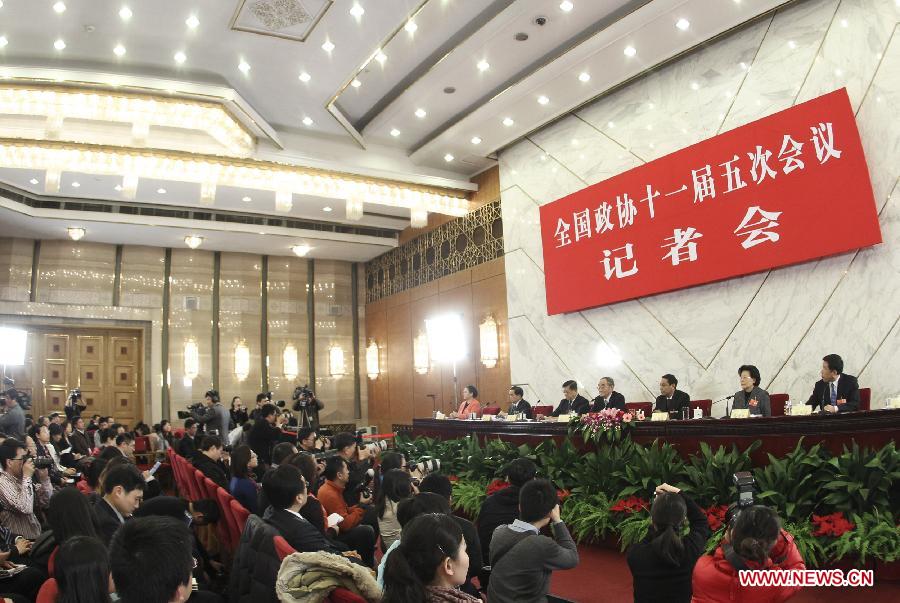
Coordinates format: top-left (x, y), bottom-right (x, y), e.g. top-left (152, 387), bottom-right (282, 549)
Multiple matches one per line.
top-left (500, 0), bottom-right (900, 415)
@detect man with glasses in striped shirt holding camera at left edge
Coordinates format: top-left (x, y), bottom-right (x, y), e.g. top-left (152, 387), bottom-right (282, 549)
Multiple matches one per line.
top-left (0, 438), bottom-right (53, 540)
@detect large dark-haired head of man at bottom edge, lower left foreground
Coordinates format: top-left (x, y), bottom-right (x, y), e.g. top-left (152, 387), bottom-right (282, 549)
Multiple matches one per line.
top-left (109, 517), bottom-right (194, 603)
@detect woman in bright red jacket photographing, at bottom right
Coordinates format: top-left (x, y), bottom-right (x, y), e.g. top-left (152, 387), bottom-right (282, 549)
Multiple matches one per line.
top-left (692, 506), bottom-right (806, 603)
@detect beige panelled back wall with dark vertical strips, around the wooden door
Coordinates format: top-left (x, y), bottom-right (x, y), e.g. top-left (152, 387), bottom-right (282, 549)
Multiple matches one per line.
top-left (0, 237), bottom-right (368, 425)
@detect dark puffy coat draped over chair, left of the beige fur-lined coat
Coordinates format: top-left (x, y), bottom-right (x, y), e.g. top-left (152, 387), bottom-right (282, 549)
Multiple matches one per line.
top-left (228, 515), bottom-right (281, 603)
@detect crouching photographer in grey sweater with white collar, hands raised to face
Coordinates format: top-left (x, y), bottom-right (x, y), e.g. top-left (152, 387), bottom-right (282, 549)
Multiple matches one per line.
top-left (488, 479), bottom-right (578, 603)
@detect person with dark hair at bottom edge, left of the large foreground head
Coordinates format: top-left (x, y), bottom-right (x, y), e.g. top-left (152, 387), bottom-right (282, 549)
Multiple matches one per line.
top-left (54, 536), bottom-right (112, 603)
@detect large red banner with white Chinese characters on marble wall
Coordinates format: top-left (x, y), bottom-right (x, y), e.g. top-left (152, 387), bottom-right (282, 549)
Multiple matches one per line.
top-left (540, 89), bottom-right (881, 314)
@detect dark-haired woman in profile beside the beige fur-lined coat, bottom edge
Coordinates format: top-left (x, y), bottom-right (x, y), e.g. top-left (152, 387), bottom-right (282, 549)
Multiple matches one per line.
top-left (382, 513), bottom-right (482, 603)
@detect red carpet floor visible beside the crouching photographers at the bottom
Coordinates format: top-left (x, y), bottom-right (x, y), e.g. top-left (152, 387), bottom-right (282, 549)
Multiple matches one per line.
top-left (550, 546), bottom-right (900, 603)
